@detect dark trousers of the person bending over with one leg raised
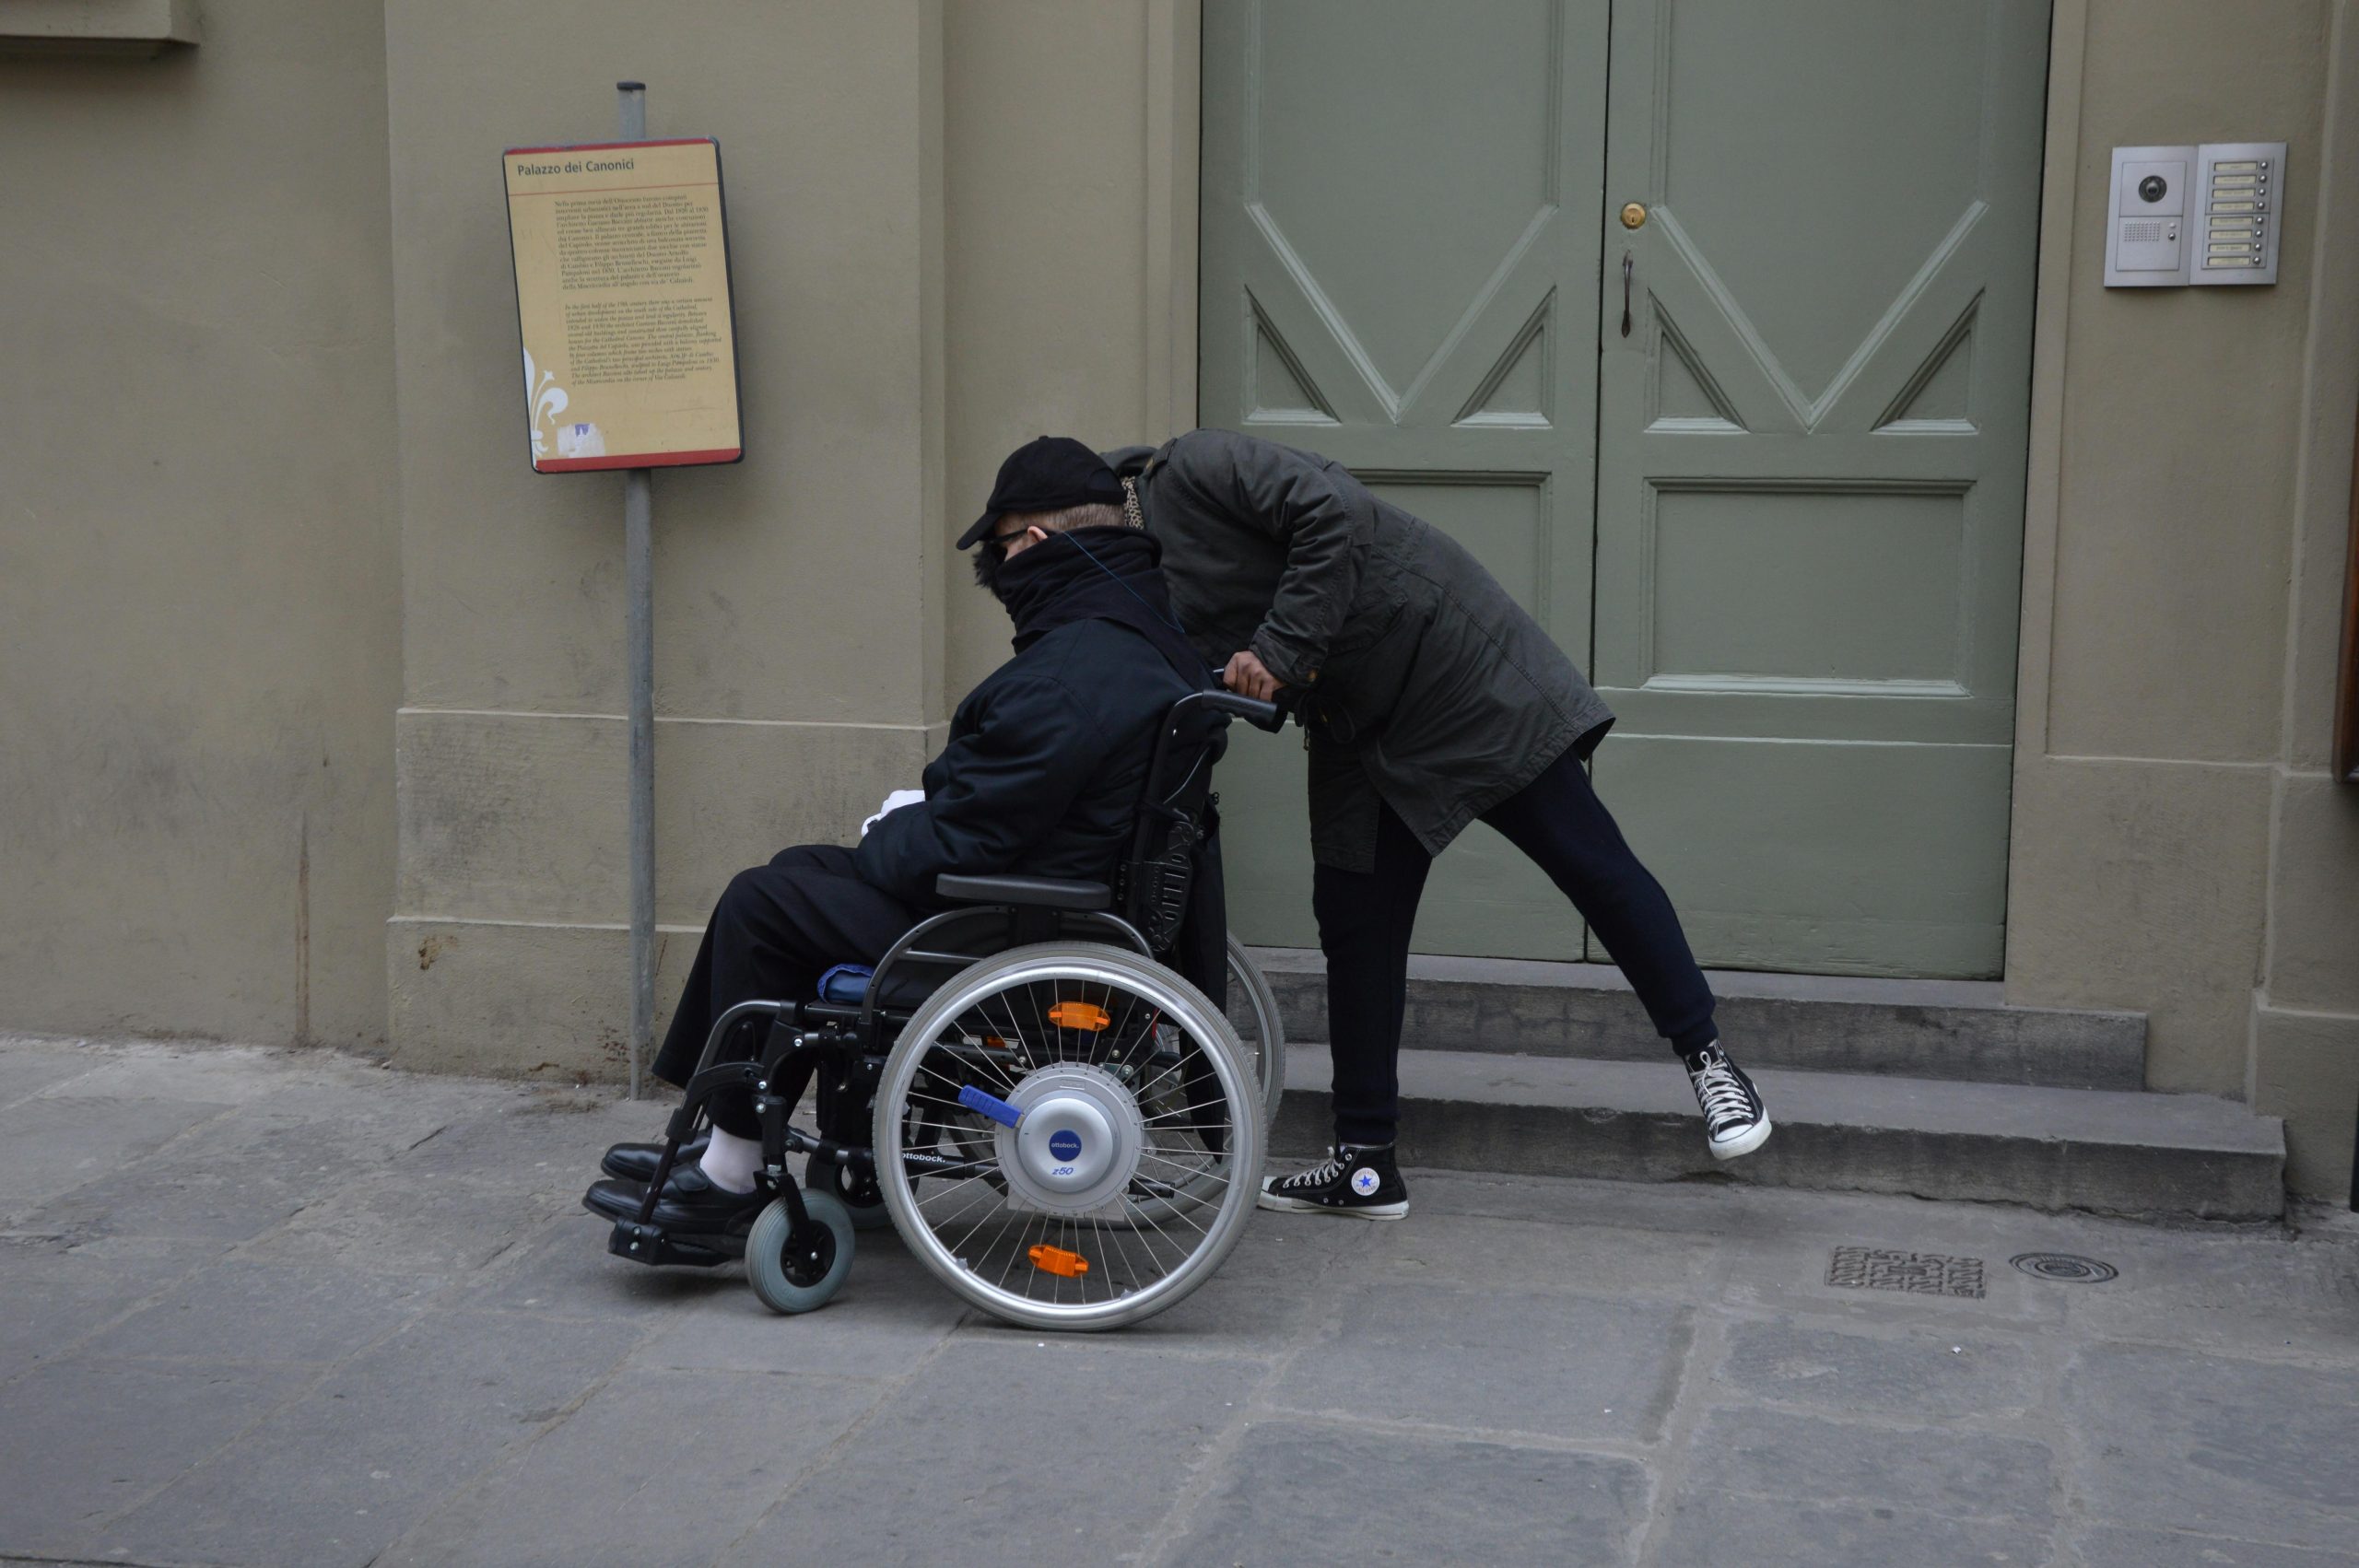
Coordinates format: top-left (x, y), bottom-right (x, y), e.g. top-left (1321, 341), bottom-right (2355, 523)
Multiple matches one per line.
top-left (1311, 752), bottom-right (1715, 1143)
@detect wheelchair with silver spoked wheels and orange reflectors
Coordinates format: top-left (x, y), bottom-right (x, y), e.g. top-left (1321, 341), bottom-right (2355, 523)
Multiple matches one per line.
top-left (606, 691), bottom-right (1285, 1330)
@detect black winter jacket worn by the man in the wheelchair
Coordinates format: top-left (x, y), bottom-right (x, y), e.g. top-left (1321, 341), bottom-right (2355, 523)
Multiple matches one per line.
top-left (856, 620), bottom-right (1189, 907)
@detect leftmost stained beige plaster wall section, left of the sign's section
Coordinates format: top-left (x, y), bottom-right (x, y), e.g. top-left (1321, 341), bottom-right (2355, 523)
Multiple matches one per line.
top-left (0, 0), bottom-right (401, 1047)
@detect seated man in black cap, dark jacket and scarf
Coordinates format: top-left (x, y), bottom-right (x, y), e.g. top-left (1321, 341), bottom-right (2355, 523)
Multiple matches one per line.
top-left (582, 439), bottom-right (1220, 1257)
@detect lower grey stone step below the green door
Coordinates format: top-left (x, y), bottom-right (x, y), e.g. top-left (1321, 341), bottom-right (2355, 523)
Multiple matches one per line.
top-left (1273, 1045), bottom-right (2286, 1219)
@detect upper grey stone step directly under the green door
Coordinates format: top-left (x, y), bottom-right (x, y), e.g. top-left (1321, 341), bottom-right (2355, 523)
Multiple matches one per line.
top-left (1255, 948), bottom-right (2147, 1089)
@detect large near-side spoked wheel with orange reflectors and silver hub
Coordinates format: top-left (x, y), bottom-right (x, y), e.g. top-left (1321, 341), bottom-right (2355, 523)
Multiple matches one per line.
top-left (875, 943), bottom-right (1262, 1330)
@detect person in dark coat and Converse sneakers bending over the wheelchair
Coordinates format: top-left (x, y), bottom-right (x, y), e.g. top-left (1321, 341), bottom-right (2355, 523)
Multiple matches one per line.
top-left (1085, 429), bottom-right (1772, 1219)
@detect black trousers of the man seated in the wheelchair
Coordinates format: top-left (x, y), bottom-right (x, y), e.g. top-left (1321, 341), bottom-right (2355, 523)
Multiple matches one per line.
top-left (653, 844), bottom-right (925, 1139)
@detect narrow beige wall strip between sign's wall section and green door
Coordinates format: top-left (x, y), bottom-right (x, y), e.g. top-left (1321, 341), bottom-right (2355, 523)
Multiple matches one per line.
top-left (944, 0), bottom-right (1201, 703)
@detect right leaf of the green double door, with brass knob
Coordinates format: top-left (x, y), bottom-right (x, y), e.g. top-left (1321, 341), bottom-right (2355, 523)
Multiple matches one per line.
top-left (1595, 0), bottom-right (2048, 977)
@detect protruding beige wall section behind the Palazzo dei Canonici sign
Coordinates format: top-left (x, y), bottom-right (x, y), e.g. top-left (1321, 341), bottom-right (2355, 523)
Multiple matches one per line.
top-left (382, 0), bottom-right (946, 1075)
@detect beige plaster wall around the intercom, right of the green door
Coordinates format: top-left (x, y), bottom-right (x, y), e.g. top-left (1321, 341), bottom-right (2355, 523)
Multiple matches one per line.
top-left (2008, 0), bottom-right (2359, 1193)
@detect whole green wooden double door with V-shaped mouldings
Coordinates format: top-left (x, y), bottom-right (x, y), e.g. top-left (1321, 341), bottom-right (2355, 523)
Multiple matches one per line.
top-left (1198, 0), bottom-right (2048, 977)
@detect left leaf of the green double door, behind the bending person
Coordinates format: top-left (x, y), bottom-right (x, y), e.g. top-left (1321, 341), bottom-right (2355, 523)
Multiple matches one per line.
top-left (1201, 0), bottom-right (1606, 957)
